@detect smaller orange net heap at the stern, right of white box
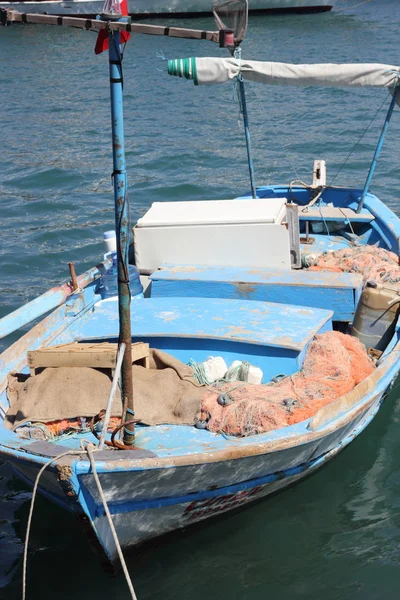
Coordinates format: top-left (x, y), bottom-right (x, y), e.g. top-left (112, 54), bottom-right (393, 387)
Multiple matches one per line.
top-left (305, 246), bottom-right (400, 283)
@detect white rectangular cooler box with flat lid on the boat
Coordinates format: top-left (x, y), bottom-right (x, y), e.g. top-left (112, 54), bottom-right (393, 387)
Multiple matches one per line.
top-left (133, 198), bottom-right (291, 271)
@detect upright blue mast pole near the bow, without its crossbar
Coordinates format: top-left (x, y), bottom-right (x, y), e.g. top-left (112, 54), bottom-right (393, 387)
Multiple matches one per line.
top-left (108, 31), bottom-right (135, 446)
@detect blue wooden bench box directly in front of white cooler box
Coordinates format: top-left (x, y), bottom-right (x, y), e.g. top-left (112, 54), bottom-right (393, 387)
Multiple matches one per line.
top-left (151, 265), bottom-right (362, 322)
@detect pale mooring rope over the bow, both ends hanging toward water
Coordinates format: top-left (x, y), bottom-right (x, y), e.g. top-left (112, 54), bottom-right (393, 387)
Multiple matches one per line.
top-left (22, 440), bottom-right (137, 600)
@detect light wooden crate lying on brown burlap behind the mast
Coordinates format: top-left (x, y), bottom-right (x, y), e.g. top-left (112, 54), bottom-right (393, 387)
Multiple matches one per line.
top-left (27, 342), bottom-right (149, 375)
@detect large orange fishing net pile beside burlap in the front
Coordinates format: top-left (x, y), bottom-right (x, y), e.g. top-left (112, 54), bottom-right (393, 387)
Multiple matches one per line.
top-left (201, 331), bottom-right (374, 437)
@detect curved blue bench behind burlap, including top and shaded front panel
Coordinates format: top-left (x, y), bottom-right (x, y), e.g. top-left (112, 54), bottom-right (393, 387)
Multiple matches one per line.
top-left (77, 298), bottom-right (332, 381)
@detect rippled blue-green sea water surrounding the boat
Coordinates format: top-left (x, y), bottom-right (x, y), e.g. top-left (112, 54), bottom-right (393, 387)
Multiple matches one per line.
top-left (0, 0), bottom-right (400, 600)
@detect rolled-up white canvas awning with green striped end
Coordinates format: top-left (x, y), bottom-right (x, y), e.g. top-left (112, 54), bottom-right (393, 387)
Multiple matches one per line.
top-left (168, 58), bottom-right (400, 103)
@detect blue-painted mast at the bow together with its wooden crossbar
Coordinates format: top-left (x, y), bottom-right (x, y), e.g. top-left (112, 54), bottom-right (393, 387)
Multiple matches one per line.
top-left (0, 0), bottom-right (220, 448)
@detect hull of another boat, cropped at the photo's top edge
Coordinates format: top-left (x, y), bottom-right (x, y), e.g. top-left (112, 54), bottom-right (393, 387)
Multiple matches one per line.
top-left (0, 0), bottom-right (335, 18)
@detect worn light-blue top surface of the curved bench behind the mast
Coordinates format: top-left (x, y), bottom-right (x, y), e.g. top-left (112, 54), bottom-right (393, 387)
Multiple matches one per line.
top-left (76, 298), bottom-right (332, 351)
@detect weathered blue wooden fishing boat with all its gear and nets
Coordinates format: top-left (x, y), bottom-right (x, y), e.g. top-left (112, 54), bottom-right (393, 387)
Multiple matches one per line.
top-left (0, 0), bottom-right (400, 580)
